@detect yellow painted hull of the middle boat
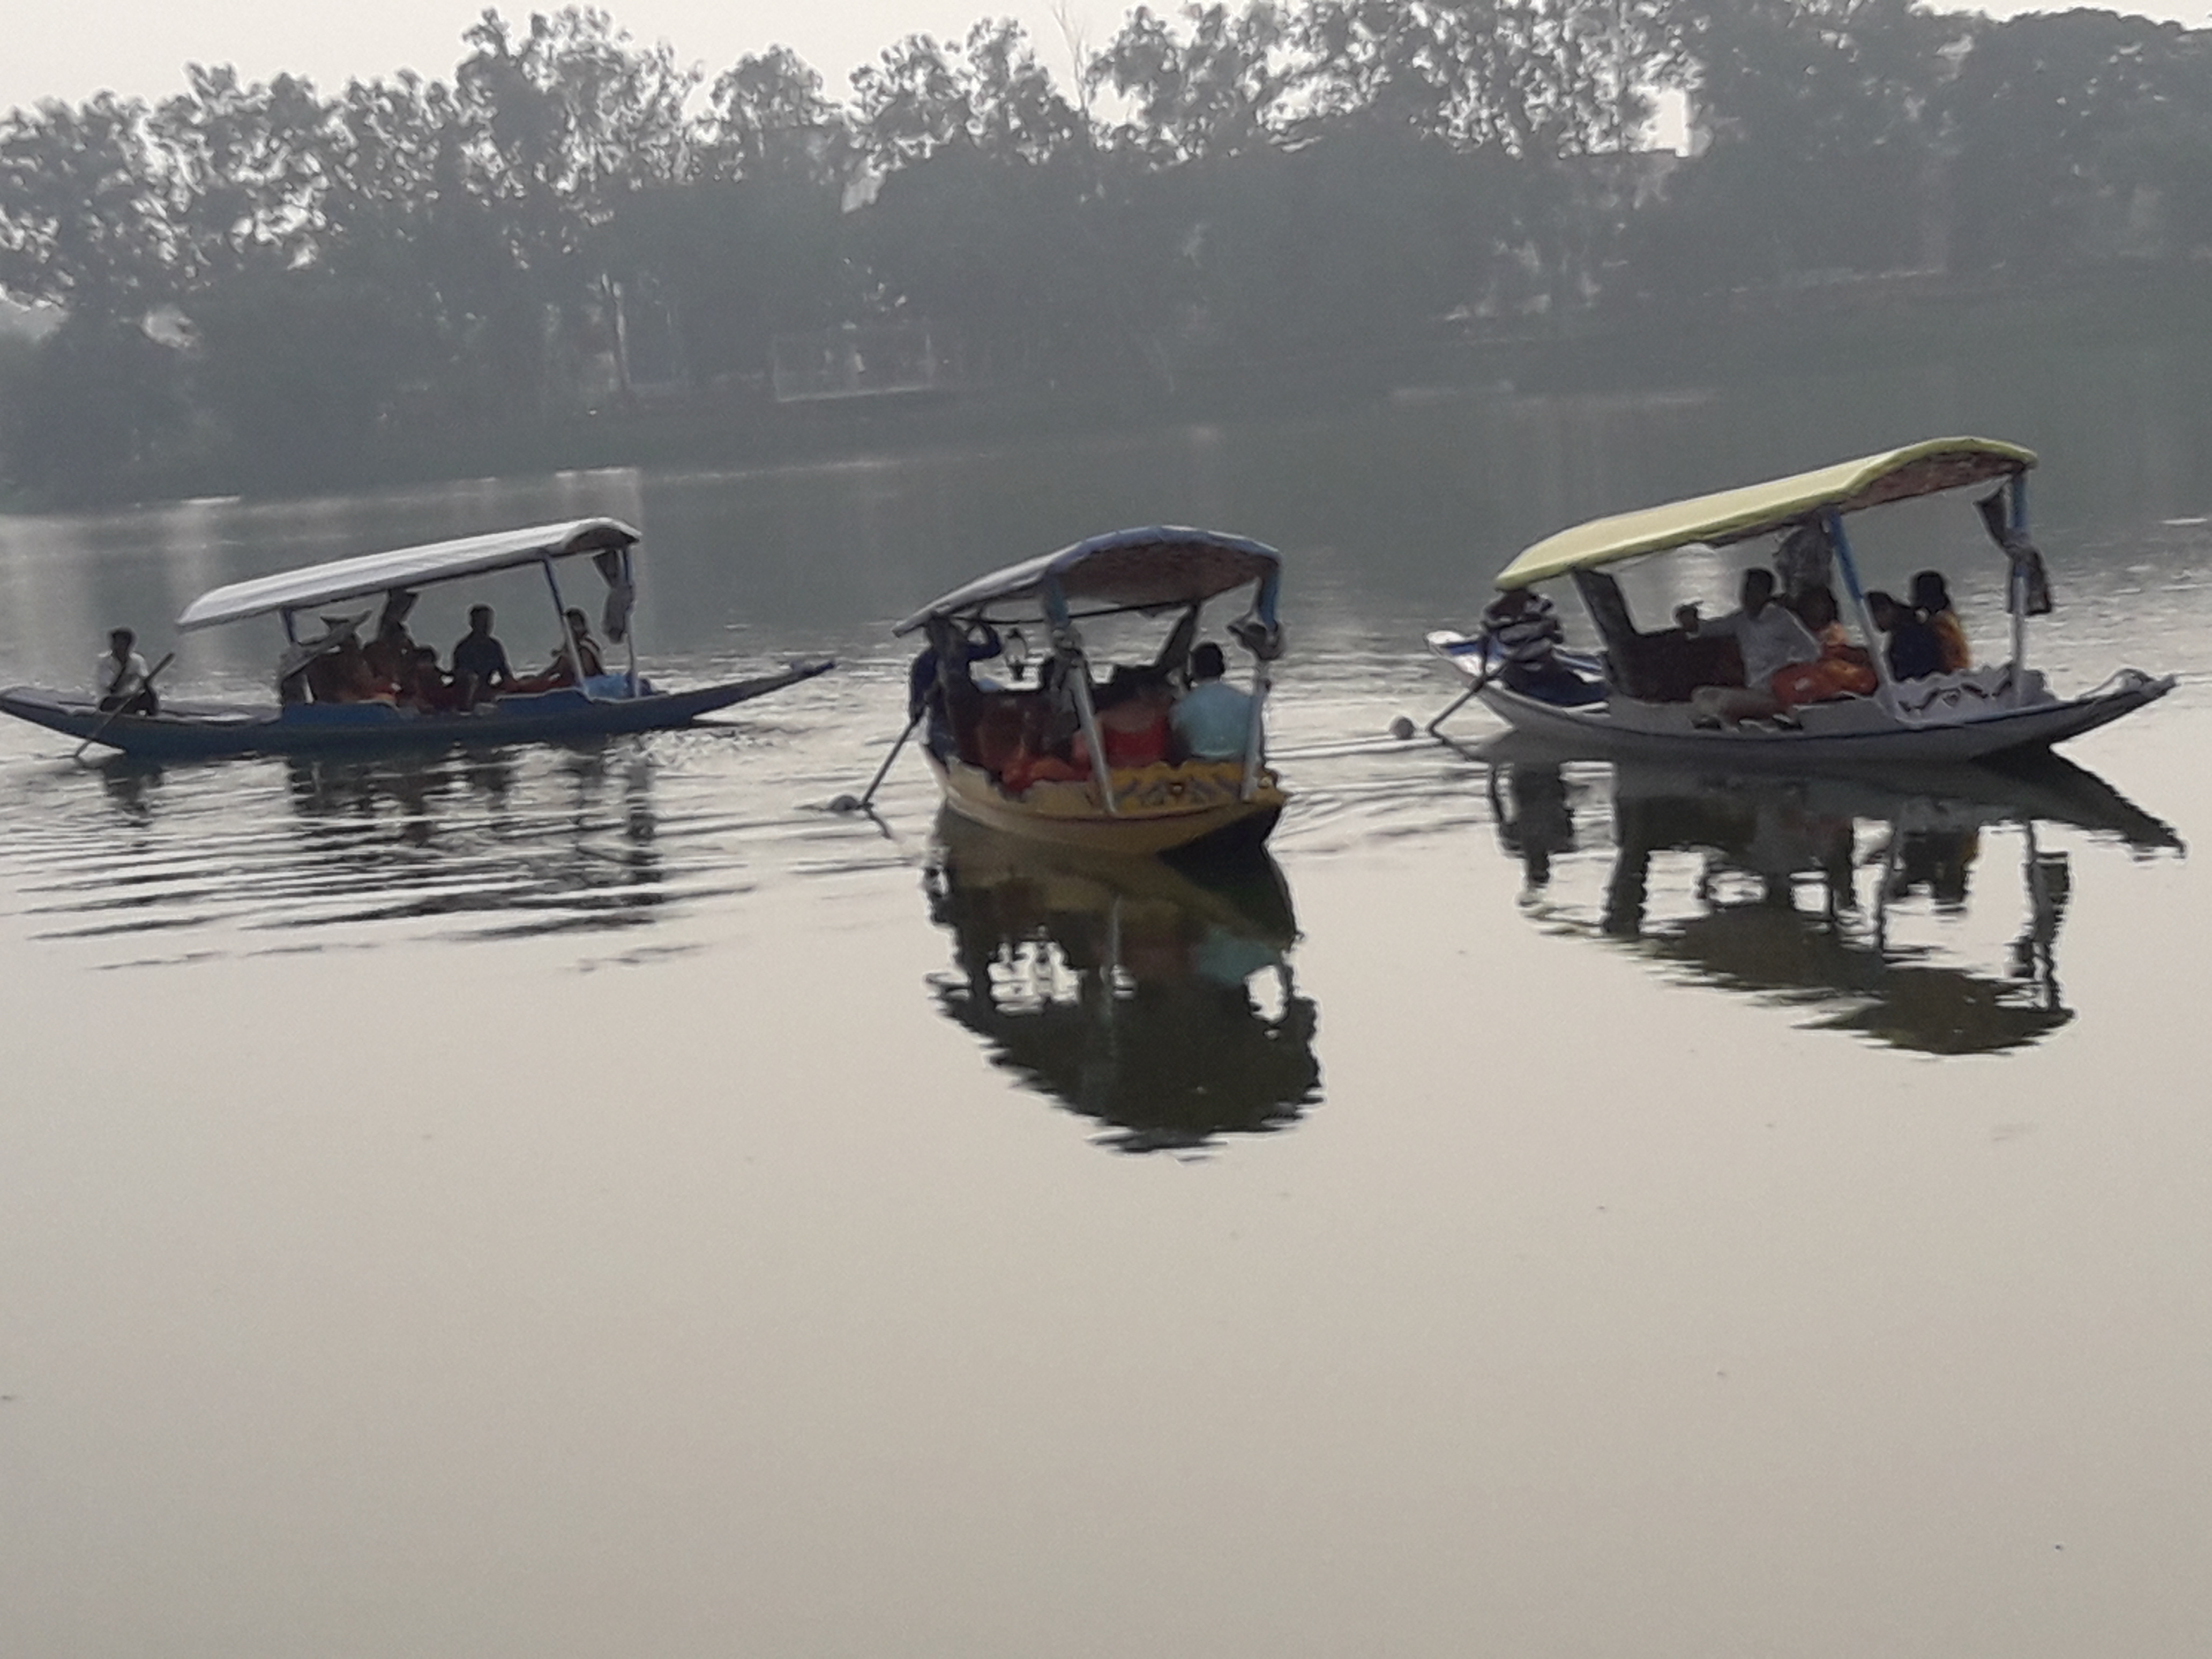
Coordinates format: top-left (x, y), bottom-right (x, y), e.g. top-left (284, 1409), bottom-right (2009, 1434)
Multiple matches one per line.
top-left (929, 754), bottom-right (1287, 856)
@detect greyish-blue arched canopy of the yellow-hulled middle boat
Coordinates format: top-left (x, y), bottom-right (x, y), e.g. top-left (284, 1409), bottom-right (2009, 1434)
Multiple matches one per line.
top-left (894, 524), bottom-right (1283, 633)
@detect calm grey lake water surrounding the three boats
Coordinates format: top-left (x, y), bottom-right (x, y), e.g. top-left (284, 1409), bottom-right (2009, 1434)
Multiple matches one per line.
top-left (0, 376), bottom-right (2212, 1659)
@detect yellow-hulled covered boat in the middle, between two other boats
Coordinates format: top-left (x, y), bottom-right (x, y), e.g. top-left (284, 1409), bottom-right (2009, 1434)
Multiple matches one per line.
top-left (871, 526), bottom-right (1285, 854)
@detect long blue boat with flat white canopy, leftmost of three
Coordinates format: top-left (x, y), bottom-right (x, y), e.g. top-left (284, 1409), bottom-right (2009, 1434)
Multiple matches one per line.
top-left (0, 518), bottom-right (834, 759)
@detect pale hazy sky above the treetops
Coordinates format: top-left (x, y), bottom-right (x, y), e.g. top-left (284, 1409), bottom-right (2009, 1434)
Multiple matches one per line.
top-left (13, 0), bottom-right (2212, 108)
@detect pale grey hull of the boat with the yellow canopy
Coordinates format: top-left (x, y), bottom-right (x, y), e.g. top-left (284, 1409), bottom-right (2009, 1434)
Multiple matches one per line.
top-left (1429, 633), bottom-right (2174, 767)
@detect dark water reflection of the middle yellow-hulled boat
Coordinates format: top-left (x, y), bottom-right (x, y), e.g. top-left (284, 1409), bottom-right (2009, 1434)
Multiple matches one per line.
top-left (929, 814), bottom-right (1320, 1153)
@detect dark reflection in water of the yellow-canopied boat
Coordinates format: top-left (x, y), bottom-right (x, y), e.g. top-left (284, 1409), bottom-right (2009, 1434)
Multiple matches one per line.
top-left (1489, 748), bottom-right (2181, 1055)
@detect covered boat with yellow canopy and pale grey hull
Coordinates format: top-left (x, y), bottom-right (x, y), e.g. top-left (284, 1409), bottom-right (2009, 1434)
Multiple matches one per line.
top-left (1429, 438), bottom-right (2174, 765)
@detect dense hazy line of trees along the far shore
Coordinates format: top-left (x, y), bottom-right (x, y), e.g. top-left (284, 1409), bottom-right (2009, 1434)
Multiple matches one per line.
top-left (0, 0), bottom-right (2212, 494)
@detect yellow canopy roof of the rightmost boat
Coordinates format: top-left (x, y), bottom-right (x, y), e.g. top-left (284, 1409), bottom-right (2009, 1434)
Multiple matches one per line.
top-left (1498, 438), bottom-right (2035, 591)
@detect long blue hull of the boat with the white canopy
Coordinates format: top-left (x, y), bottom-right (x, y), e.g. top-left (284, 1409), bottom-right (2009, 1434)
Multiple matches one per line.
top-left (0, 661), bottom-right (834, 761)
